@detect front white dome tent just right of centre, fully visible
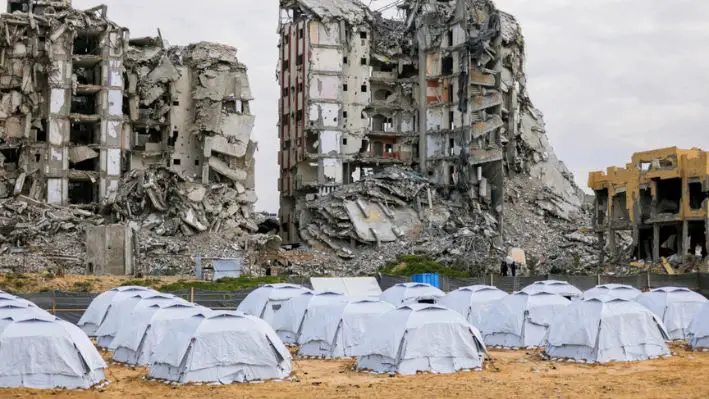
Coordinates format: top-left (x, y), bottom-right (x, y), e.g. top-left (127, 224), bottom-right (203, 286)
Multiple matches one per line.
top-left (354, 303), bottom-right (487, 375)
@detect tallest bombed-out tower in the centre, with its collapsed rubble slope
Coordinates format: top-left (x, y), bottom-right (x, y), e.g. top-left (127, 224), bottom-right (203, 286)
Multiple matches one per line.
top-left (278, 0), bottom-right (590, 276)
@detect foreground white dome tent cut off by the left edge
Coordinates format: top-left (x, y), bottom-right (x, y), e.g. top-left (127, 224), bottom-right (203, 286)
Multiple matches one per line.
top-left (0, 314), bottom-right (106, 389)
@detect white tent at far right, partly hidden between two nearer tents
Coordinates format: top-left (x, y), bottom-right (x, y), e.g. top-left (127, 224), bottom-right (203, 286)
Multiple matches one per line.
top-left (636, 287), bottom-right (707, 340)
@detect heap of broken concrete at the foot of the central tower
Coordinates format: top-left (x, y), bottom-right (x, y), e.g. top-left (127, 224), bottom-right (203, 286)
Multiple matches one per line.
top-left (289, 167), bottom-right (598, 275)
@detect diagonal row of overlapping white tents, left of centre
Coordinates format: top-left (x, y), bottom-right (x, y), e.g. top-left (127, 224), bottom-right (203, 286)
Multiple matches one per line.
top-left (78, 286), bottom-right (291, 383)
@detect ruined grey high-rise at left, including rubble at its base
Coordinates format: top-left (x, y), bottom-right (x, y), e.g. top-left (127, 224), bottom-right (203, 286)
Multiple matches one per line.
top-left (0, 0), bottom-right (258, 276)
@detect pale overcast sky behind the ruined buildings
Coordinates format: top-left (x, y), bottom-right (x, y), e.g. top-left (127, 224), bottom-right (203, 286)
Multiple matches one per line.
top-left (73, 0), bottom-right (709, 212)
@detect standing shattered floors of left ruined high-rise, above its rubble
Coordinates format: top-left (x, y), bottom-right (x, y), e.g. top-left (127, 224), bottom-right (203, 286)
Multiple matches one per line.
top-left (0, 0), bottom-right (254, 204)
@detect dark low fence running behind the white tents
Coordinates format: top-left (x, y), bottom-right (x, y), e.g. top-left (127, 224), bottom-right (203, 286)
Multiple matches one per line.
top-left (20, 273), bottom-right (709, 323)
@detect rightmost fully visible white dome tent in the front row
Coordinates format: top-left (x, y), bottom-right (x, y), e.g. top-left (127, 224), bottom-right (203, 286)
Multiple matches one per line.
top-left (545, 296), bottom-right (670, 363)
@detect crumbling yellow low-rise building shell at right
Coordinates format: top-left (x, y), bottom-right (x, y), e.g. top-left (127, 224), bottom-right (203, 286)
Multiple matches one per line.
top-left (588, 147), bottom-right (709, 262)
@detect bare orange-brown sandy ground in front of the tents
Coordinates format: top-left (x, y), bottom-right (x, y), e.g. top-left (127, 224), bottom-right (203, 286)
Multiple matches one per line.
top-left (5, 346), bottom-right (709, 399)
